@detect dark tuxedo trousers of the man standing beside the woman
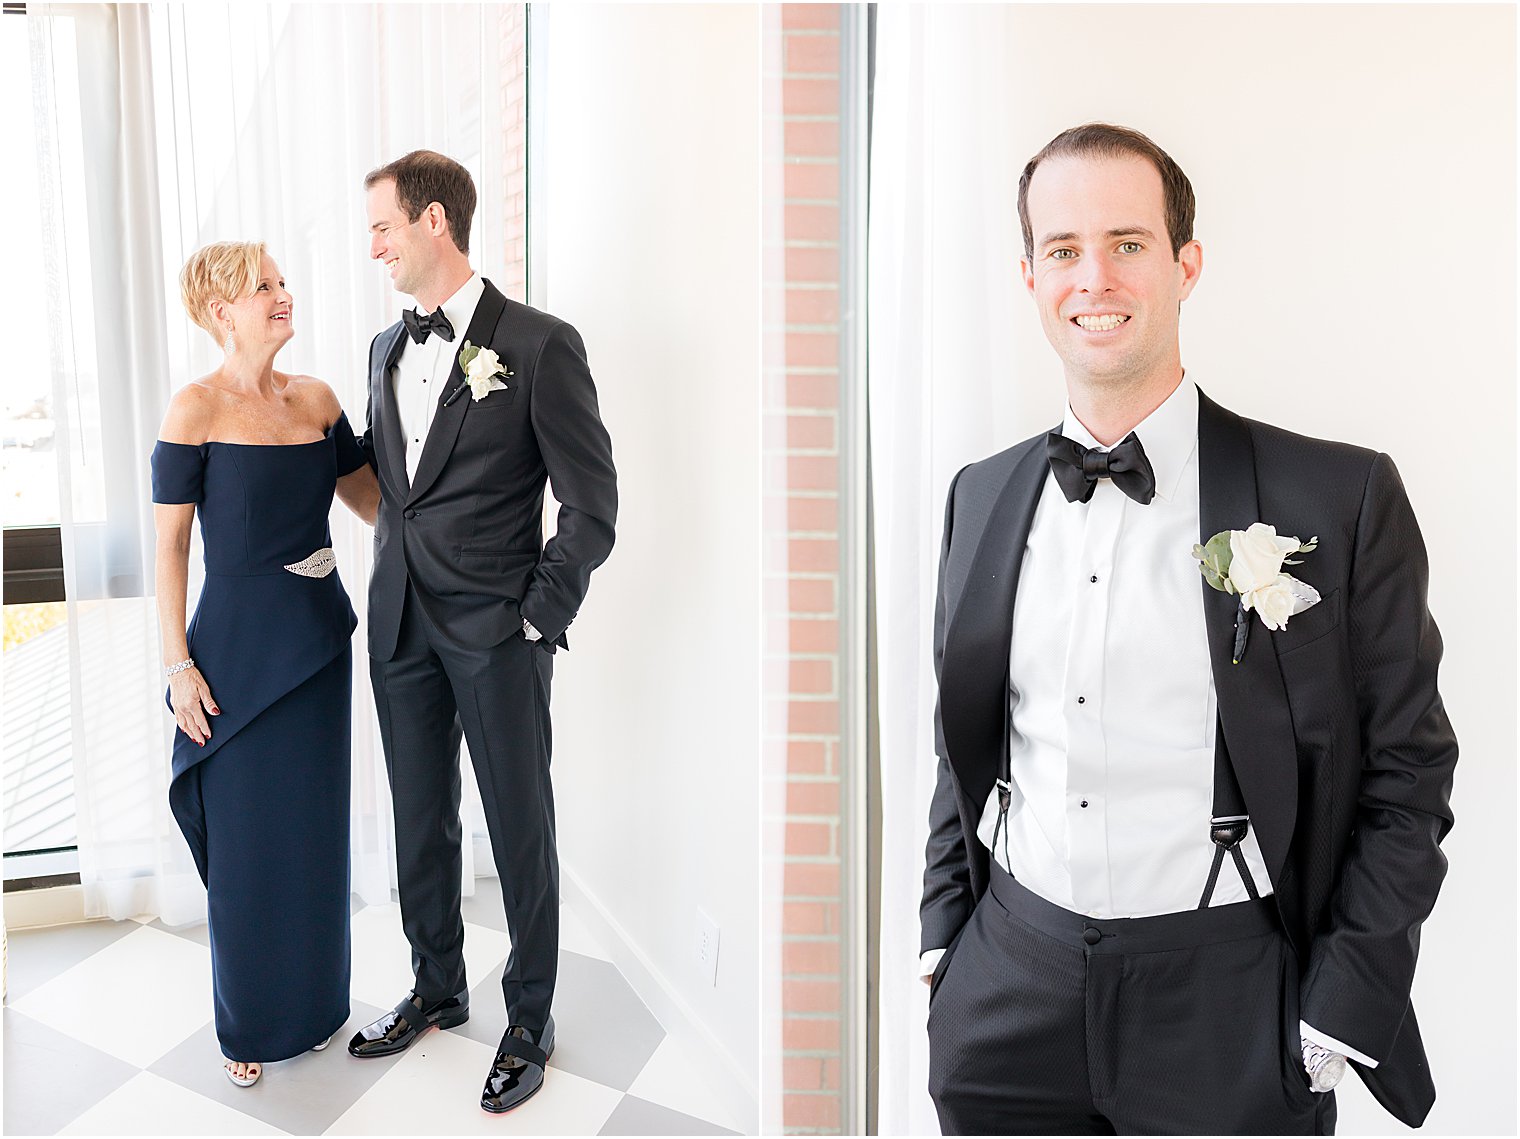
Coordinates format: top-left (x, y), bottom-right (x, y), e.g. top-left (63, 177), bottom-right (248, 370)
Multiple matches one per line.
top-left (369, 582), bottom-right (559, 1033)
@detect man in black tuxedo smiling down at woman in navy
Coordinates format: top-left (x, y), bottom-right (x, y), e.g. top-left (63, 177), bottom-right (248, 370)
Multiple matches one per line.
top-left (348, 151), bottom-right (617, 1112)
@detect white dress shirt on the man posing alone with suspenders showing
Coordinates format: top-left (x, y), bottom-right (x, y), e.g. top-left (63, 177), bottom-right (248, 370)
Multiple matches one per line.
top-left (920, 379), bottom-right (1366, 1063)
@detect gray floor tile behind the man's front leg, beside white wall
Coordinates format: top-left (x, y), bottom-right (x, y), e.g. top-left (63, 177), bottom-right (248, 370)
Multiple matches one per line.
top-left (454, 950), bottom-right (664, 1092)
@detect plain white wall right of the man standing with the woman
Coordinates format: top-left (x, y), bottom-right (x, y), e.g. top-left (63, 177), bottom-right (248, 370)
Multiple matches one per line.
top-left (530, 5), bottom-right (760, 1125)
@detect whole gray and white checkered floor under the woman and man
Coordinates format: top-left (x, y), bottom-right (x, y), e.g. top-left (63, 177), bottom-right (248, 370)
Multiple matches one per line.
top-left (5, 882), bottom-right (737, 1134)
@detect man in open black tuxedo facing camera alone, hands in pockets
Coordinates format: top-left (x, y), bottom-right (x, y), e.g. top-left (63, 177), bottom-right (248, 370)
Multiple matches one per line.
top-left (921, 123), bottom-right (1456, 1134)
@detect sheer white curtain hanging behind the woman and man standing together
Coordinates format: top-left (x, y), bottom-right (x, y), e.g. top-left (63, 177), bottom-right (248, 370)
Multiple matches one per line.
top-left (27, 5), bottom-right (505, 923)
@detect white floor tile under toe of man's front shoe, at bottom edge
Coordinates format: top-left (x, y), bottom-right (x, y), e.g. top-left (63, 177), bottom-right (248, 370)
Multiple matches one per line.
top-left (327, 1033), bottom-right (623, 1134)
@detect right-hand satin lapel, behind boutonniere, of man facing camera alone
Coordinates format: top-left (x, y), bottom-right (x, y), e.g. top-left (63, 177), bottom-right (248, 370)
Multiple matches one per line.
top-left (1198, 392), bottom-right (1298, 884)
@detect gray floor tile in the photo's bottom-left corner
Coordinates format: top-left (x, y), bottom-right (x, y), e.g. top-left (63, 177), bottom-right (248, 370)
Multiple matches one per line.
top-left (5, 1009), bottom-right (139, 1134)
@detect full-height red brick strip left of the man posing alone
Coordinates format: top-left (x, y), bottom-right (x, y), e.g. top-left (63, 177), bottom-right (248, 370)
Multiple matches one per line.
top-left (777, 5), bottom-right (844, 1134)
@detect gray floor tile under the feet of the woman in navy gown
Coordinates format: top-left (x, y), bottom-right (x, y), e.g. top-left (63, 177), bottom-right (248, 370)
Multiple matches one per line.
top-left (147, 1001), bottom-right (400, 1134)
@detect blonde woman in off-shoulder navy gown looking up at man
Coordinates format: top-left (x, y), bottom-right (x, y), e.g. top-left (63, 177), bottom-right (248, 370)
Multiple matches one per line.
top-left (152, 242), bottom-right (378, 1087)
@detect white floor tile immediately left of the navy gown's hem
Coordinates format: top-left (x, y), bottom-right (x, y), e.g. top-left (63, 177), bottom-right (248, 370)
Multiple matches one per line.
top-left (15, 926), bottom-right (214, 1068)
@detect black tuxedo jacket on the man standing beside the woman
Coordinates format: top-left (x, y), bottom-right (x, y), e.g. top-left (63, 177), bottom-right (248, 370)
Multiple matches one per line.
top-left (362, 281), bottom-right (617, 660)
